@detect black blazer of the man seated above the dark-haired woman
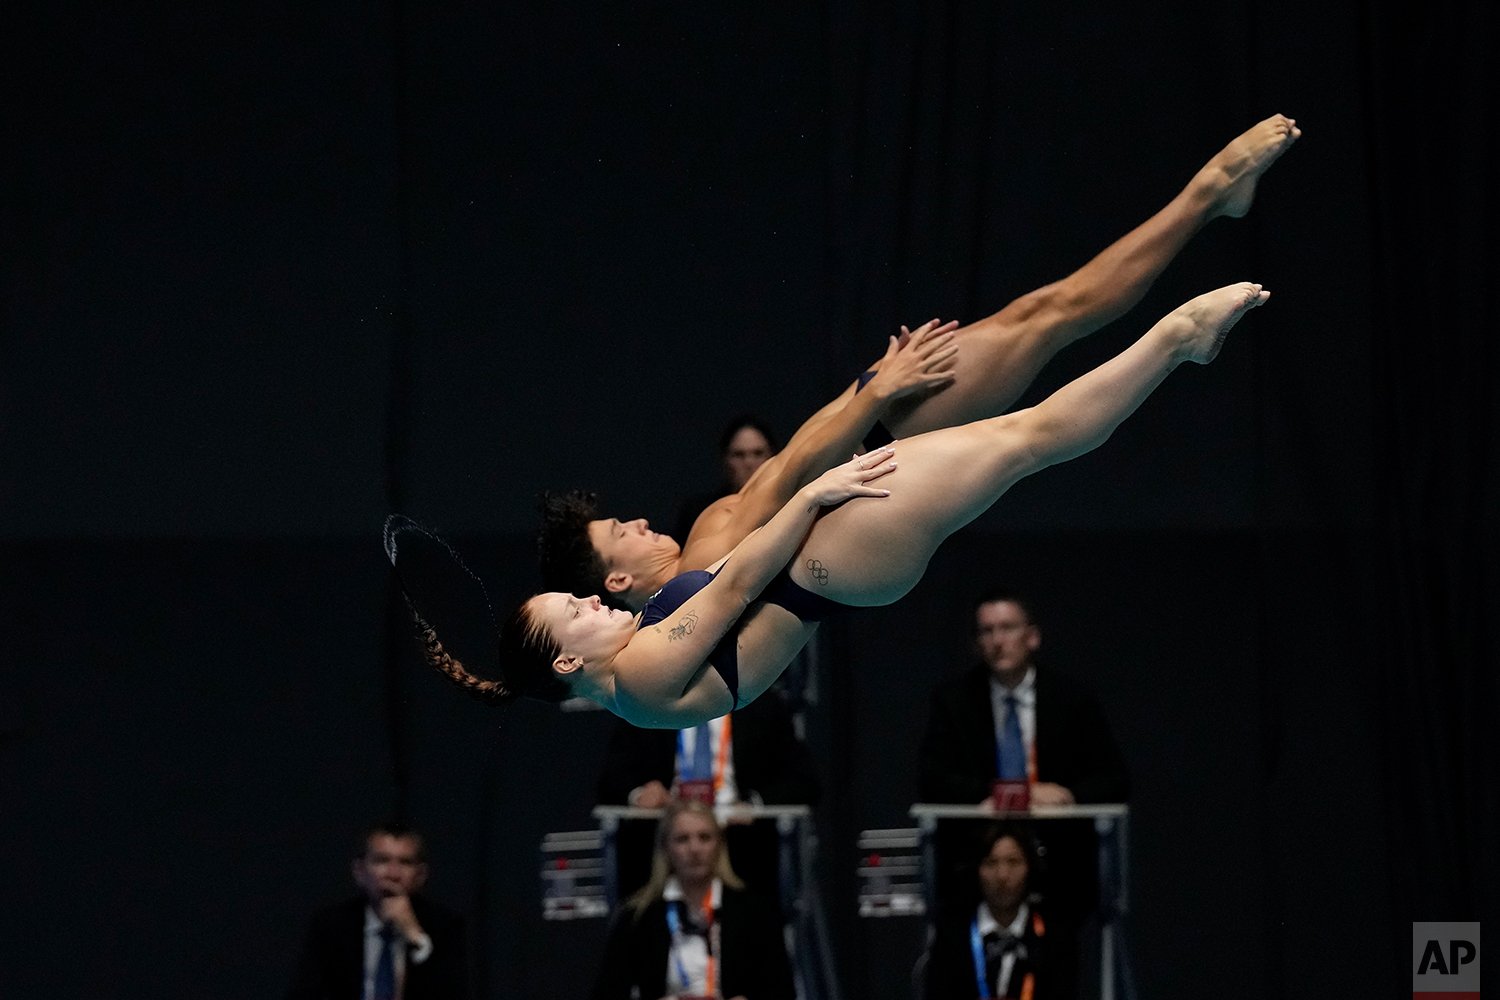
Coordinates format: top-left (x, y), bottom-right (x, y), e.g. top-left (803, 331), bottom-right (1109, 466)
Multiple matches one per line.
top-left (921, 663), bottom-right (1130, 804)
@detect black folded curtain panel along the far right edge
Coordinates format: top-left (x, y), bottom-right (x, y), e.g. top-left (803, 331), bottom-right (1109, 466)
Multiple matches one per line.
top-left (1367, 4), bottom-right (1500, 977)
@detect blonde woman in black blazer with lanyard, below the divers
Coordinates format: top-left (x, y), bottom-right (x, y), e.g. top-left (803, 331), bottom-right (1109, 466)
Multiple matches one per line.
top-left (593, 801), bottom-right (797, 1000)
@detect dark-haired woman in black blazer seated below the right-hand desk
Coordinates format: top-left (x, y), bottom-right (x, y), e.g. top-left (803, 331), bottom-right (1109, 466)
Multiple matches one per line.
top-left (923, 823), bottom-right (1077, 1000)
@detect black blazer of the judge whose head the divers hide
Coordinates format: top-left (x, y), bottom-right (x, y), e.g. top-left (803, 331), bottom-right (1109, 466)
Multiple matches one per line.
top-left (599, 691), bottom-right (819, 805)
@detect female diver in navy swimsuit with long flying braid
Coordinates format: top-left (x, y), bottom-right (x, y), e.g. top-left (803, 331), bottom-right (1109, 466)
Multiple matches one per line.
top-left (386, 282), bottom-right (1271, 729)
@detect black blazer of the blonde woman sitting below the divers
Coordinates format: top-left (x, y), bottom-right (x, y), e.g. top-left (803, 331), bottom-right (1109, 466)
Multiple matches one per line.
top-left (593, 886), bottom-right (797, 1000)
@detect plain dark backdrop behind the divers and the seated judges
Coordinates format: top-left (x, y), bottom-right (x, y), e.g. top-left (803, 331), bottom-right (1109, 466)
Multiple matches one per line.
top-left (0, 0), bottom-right (1500, 999)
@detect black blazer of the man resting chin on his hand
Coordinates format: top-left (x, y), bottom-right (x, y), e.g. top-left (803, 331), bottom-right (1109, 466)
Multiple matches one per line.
top-left (287, 895), bottom-right (471, 1000)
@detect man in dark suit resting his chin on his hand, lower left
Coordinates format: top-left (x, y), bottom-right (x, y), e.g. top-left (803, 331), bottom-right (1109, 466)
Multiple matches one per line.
top-left (287, 823), bottom-right (470, 1000)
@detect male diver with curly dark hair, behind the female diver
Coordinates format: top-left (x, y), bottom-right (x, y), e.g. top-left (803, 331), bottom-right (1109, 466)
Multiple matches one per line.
top-left (540, 114), bottom-right (1302, 610)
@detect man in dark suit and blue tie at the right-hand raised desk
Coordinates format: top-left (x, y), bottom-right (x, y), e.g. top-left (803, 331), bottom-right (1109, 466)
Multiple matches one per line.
top-left (921, 591), bottom-right (1130, 983)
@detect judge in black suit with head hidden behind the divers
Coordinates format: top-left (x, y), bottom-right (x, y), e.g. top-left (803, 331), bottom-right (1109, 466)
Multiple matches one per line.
top-left (599, 691), bottom-right (819, 897)
